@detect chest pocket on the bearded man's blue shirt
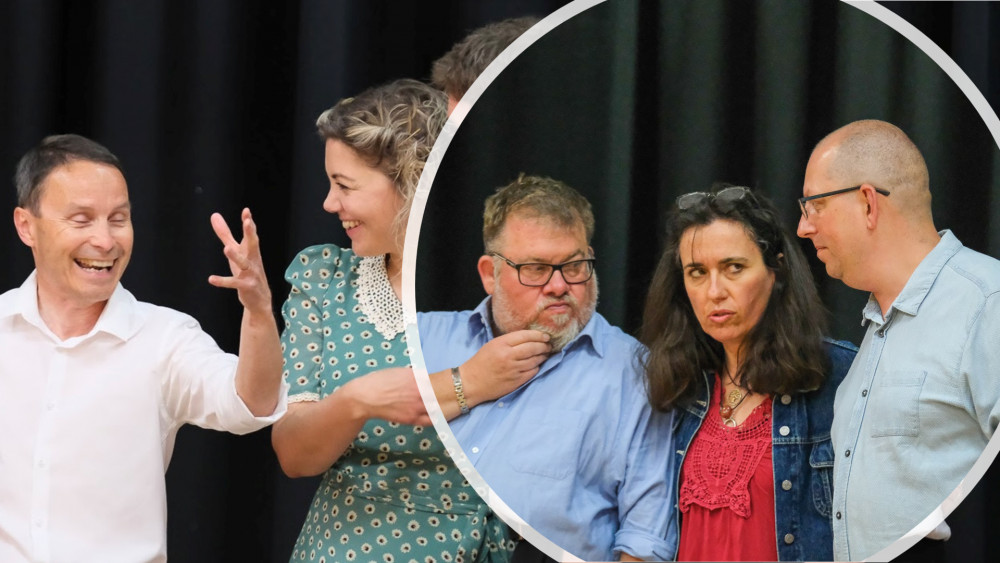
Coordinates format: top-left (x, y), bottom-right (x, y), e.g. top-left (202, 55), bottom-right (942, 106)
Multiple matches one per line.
top-left (506, 410), bottom-right (586, 479)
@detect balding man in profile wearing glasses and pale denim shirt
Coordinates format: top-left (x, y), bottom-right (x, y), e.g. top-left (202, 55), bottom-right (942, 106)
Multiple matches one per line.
top-left (798, 120), bottom-right (1000, 561)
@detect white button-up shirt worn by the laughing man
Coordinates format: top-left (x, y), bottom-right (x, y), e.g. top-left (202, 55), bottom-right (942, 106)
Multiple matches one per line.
top-left (0, 272), bottom-right (287, 563)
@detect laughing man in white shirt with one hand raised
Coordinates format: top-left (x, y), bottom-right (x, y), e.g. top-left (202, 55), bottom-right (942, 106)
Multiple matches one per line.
top-left (0, 135), bottom-right (286, 563)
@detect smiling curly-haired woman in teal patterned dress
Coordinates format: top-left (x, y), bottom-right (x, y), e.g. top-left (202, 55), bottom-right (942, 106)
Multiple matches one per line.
top-left (272, 80), bottom-right (513, 561)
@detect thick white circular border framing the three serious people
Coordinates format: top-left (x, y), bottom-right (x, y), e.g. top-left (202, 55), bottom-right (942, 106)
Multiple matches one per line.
top-left (403, 0), bottom-right (1000, 562)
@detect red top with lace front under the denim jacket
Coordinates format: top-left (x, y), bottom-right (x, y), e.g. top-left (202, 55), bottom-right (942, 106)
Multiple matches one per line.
top-left (677, 375), bottom-right (778, 561)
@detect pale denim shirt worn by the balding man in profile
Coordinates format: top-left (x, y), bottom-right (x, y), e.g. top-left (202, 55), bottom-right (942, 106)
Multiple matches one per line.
top-left (831, 231), bottom-right (1000, 561)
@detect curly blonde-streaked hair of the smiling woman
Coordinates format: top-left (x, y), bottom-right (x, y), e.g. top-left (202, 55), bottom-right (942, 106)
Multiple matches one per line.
top-left (316, 79), bottom-right (448, 236)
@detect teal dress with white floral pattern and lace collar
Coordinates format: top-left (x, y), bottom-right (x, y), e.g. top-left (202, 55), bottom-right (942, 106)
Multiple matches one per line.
top-left (281, 245), bottom-right (514, 563)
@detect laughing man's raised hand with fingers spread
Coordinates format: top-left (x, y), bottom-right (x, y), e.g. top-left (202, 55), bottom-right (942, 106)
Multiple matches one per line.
top-left (208, 208), bottom-right (273, 316)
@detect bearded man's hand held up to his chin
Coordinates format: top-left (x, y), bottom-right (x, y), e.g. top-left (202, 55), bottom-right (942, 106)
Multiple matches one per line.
top-left (459, 330), bottom-right (552, 406)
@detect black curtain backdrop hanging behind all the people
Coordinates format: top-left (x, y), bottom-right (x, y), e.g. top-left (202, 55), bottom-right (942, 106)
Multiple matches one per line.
top-left (0, 0), bottom-right (1000, 563)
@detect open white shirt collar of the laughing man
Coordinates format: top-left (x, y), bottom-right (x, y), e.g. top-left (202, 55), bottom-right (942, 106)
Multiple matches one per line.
top-left (0, 270), bottom-right (143, 345)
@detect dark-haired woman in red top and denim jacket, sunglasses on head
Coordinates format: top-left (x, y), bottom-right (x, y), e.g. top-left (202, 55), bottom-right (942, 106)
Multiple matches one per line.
top-left (641, 186), bottom-right (856, 561)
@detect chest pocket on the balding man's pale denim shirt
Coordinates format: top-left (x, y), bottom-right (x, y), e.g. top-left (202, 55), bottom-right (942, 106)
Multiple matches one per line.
top-left (865, 371), bottom-right (927, 438)
